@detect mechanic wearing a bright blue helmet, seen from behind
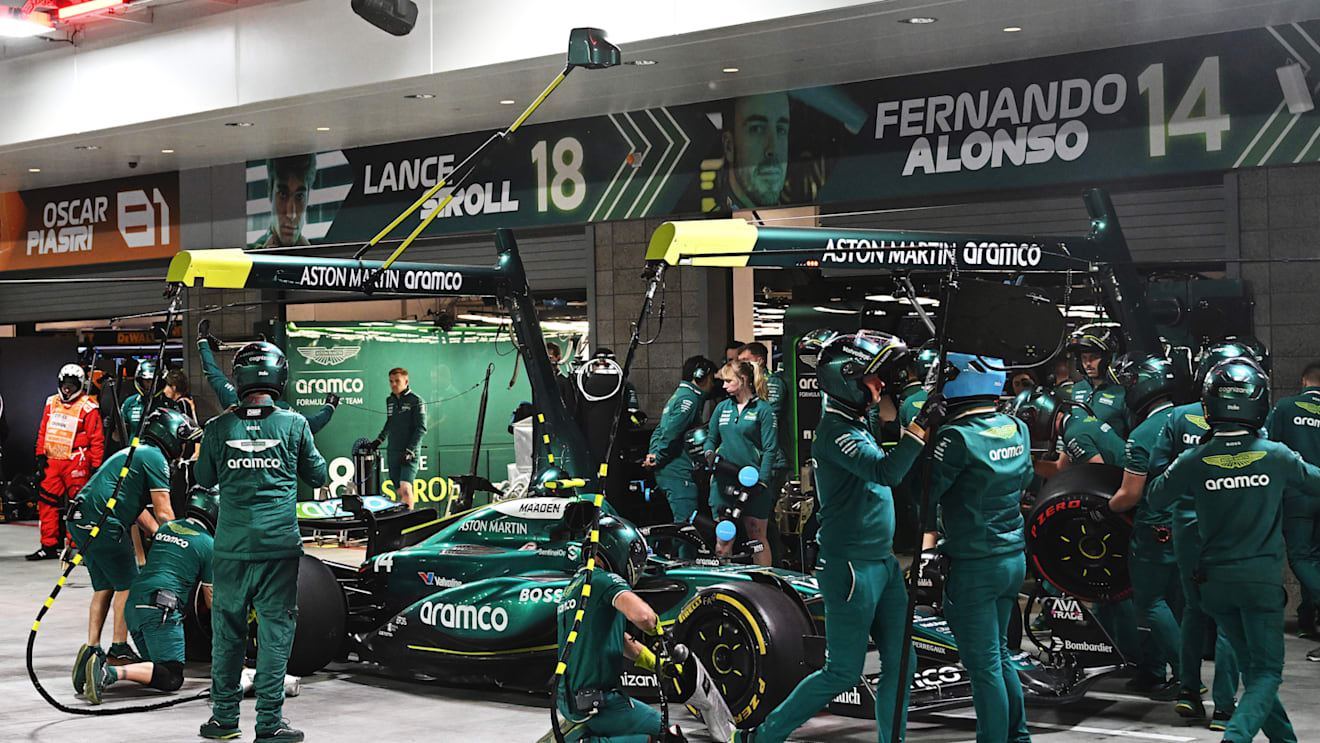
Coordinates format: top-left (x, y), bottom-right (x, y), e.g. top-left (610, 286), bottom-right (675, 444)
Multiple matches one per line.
top-left (927, 354), bottom-right (1032, 743)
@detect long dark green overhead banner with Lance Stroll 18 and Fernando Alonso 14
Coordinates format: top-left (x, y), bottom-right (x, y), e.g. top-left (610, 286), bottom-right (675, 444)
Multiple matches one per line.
top-left (247, 21), bottom-right (1320, 245)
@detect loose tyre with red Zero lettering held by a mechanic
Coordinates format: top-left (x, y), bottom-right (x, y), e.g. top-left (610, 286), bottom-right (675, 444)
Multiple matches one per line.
top-left (1027, 463), bottom-right (1133, 600)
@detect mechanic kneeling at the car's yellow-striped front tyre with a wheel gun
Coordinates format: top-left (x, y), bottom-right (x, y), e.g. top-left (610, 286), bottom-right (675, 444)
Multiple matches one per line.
top-left (543, 516), bottom-right (684, 743)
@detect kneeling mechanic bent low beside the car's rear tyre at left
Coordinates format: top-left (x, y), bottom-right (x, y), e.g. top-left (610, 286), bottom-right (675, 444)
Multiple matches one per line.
top-left (86, 519), bottom-right (213, 705)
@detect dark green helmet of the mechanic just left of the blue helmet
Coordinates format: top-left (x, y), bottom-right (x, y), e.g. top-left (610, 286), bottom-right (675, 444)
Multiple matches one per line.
top-left (816, 330), bottom-right (908, 416)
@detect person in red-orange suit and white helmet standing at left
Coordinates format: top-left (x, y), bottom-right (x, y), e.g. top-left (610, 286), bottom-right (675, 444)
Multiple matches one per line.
top-left (26, 364), bottom-right (106, 560)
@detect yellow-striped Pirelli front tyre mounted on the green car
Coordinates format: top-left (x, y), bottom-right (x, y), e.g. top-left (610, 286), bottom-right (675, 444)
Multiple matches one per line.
top-left (675, 581), bottom-right (812, 727)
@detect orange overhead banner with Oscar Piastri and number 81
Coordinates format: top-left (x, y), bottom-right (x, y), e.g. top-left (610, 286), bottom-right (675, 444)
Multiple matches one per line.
top-left (0, 173), bottom-right (180, 271)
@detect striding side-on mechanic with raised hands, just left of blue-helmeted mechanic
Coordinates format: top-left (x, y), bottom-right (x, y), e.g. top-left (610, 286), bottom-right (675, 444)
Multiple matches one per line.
top-left (734, 330), bottom-right (940, 743)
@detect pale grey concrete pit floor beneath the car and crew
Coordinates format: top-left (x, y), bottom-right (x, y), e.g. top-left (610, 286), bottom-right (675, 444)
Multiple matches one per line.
top-left (0, 524), bottom-right (1320, 743)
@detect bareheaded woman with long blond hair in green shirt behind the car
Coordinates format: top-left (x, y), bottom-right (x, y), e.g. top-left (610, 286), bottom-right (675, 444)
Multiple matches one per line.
top-left (705, 362), bottom-right (779, 567)
